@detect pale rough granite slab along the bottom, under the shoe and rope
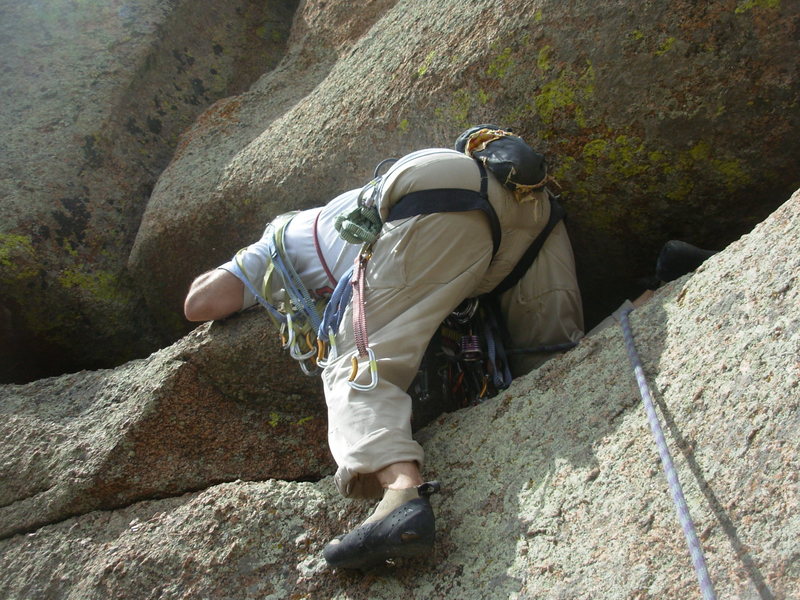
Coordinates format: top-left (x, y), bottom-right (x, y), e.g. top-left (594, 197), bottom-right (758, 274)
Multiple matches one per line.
top-left (0, 192), bottom-right (800, 600)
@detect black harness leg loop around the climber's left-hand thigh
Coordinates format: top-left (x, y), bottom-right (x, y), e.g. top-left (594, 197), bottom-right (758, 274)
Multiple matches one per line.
top-left (386, 161), bottom-right (502, 256)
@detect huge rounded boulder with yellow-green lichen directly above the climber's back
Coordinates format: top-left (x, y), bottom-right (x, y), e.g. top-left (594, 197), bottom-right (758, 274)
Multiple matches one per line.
top-left (129, 0), bottom-right (800, 342)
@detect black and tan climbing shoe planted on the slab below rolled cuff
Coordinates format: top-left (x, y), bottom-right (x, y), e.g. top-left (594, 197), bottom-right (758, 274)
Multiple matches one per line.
top-left (323, 481), bottom-right (439, 569)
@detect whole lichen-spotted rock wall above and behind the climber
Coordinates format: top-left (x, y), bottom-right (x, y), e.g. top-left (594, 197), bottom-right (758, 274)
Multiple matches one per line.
top-left (0, 0), bottom-right (800, 381)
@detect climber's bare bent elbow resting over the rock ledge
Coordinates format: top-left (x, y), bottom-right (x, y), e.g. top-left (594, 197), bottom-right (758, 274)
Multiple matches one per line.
top-left (183, 269), bottom-right (244, 321)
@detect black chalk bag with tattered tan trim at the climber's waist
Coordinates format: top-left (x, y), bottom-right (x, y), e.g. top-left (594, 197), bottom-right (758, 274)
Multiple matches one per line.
top-left (455, 124), bottom-right (547, 190)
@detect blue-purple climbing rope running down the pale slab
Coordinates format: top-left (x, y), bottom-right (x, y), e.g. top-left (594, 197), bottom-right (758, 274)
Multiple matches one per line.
top-left (619, 307), bottom-right (717, 600)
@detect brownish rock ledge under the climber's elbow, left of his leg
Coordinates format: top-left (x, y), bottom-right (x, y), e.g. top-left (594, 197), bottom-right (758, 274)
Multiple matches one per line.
top-left (0, 311), bottom-right (333, 537)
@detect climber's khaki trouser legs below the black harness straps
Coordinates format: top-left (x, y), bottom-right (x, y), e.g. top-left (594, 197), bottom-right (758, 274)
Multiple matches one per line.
top-left (322, 211), bottom-right (583, 497)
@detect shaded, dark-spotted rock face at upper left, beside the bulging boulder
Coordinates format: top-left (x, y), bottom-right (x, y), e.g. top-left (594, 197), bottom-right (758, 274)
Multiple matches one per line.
top-left (0, 0), bottom-right (297, 382)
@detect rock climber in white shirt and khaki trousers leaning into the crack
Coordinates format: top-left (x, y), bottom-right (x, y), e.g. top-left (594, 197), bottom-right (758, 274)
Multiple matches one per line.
top-left (184, 125), bottom-right (583, 568)
